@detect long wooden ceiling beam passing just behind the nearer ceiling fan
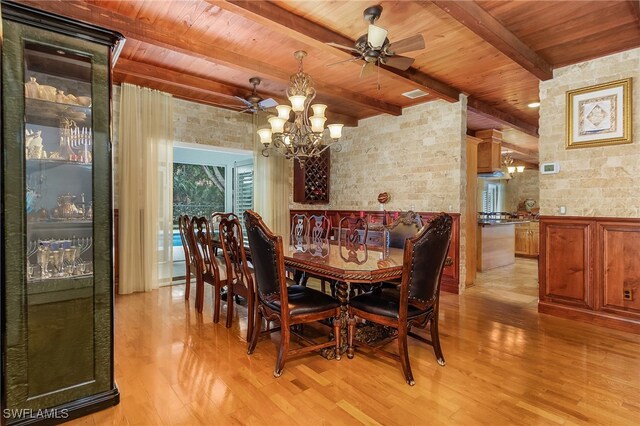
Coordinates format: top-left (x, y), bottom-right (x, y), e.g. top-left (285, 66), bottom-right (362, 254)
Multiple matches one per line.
top-left (219, 0), bottom-right (460, 102)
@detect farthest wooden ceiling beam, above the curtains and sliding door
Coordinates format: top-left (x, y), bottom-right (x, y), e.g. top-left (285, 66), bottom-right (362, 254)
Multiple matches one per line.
top-left (114, 58), bottom-right (358, 127)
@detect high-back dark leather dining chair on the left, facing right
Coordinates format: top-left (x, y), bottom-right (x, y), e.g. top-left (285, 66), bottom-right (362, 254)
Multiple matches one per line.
top-left (244, 210), bottom-right (340, 377)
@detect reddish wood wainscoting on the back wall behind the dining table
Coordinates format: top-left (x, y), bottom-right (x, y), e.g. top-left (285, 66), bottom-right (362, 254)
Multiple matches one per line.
top-left (289, 209), bottom-right (460, 294)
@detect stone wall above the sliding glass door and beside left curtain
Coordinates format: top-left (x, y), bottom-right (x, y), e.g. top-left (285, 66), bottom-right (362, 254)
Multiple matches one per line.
top-left (113, 86), bottom-right (253, 208)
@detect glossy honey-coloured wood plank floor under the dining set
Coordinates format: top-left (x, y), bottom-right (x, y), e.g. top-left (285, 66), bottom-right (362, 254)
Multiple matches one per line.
top-left (72, 259), bottom-right (640, 425)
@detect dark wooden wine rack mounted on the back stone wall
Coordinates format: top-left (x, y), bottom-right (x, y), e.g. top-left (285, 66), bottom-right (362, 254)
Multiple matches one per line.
top-left (293, 149), bottom-right (331, 204)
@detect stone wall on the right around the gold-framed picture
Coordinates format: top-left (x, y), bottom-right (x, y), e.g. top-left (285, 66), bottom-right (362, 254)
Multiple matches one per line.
top-left (539, 48), bottom-right (640, 217)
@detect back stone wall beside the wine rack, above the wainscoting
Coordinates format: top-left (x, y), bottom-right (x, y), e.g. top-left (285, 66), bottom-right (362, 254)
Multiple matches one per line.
top-left (290, 96), bottom-right (475, 283)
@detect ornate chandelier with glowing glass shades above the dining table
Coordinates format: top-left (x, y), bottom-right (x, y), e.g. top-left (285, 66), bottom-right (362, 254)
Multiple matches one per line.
top-left (258, 50), bottom-right (343, 166)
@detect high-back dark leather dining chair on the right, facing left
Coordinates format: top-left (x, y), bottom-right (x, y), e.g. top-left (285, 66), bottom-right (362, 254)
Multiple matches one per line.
top-left (347, 213), bottom-right (452, 386)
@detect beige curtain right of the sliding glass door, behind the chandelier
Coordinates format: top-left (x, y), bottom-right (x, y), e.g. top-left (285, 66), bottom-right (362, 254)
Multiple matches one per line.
top-left (253, 113), bottom-right (291, 236)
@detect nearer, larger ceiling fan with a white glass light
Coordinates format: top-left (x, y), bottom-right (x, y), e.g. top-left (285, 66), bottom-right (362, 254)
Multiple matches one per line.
top-left (327, 5), bottom-right (425, 77)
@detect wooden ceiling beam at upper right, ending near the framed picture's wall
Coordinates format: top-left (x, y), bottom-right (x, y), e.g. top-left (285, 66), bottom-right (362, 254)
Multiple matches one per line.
top-left (432, 0), bottom-right (553, 80)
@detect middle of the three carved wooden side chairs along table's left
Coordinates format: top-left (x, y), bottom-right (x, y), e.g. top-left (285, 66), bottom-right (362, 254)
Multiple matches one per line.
top-left (191, 216), bottom-right (227, 323)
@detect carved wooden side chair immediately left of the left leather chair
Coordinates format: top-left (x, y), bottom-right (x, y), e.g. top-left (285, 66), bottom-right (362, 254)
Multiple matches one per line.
top-left (218, 214), bottom-right (255, 343)
